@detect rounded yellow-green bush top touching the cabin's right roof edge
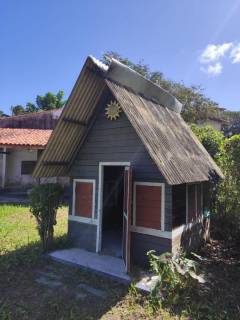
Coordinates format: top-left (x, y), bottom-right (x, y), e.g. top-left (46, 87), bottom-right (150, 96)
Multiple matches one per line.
top-left (191, 124), bottom-right (224, 161)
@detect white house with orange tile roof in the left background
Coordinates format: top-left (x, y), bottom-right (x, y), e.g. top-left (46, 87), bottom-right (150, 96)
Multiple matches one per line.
top-left (0, 109), bottom-right (66, 189)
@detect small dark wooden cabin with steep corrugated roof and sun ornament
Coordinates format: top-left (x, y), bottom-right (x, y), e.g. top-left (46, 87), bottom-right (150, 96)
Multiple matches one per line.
top-left (34, 57), bottom-right (223, 271)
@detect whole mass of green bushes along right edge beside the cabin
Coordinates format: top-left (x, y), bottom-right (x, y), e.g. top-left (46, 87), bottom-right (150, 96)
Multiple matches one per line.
top-left (191, 125), bottom-right (240, 242)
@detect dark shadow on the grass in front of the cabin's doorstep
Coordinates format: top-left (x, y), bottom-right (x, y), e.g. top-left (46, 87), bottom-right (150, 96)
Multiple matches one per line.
top-left (0, 235), bottom-right (131, 320)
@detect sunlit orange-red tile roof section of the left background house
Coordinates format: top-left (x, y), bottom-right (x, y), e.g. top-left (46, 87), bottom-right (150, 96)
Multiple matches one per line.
top-left (0, 128), bottom-right (52, 148)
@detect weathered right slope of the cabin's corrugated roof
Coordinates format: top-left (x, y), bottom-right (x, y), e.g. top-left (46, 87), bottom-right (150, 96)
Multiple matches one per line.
top-left (105, 80), bottom-right (223, 185)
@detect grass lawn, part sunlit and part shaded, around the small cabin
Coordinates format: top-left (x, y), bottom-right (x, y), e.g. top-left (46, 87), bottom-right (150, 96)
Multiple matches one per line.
top-left (0, 206), bottom-right (240, 320)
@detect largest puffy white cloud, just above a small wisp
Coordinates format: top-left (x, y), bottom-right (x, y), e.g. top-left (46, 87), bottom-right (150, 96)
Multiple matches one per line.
top-left (200, 42), bottom-right (233, 63)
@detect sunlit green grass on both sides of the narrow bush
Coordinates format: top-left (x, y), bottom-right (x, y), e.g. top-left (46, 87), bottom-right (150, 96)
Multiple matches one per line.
top-left (0, 205), bottom-right (67, 270)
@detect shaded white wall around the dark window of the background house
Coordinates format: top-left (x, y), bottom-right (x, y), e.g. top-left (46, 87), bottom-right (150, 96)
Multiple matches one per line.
top-left (6, 149), bottom-right (37, 187)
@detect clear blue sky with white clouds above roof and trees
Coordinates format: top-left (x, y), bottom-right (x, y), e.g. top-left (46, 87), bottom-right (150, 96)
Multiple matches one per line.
top-left (0, 0), bottom-right (240, 112)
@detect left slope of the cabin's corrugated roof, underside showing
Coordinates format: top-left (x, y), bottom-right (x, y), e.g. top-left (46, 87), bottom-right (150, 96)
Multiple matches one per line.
top-left (33, 57), bottom-right (107, 177)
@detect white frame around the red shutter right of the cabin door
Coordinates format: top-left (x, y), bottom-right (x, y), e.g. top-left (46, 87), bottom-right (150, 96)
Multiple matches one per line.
top-left (133, 181), bottom-right (165, 231)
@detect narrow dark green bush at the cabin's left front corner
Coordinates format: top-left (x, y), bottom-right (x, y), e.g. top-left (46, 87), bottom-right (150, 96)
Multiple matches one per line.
top-left (29, 183), bottom-right (63, 251)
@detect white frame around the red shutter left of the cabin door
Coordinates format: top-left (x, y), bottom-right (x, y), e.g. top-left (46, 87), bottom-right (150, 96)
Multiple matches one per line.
top-left (69, 179), bottom-right (96, 224)
